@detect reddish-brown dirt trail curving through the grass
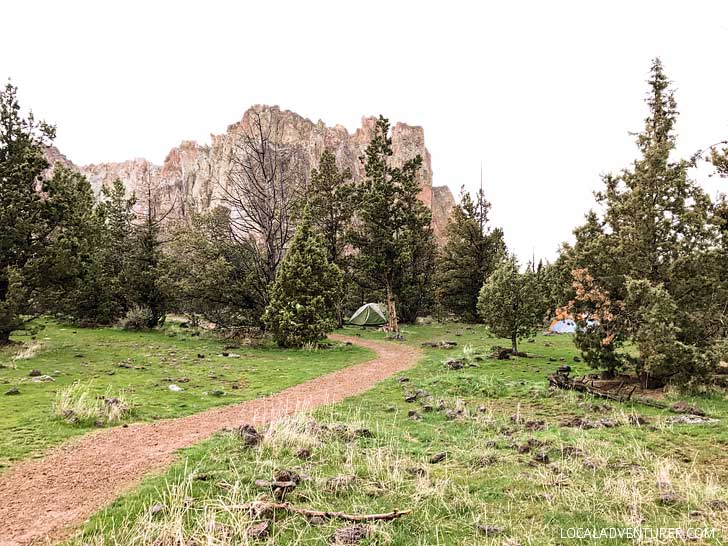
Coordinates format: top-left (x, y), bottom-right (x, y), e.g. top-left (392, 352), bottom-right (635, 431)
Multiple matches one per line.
top-left (0, 336), bottom-right (420, 546)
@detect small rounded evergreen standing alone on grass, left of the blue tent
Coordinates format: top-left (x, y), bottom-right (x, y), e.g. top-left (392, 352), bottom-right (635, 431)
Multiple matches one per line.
top-left (478, 257), bottom-right (544, 353)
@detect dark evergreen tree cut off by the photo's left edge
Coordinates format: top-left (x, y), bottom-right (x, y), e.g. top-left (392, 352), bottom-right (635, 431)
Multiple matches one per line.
top-left (0, 83), bottom-right (93, 344)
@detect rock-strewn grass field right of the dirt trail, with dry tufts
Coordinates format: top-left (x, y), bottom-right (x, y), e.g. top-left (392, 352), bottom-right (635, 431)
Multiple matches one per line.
top-left (65, 325), bottom-right (728, 546)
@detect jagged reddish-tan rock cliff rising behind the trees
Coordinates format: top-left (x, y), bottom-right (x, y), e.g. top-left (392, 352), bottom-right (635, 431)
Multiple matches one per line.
top-left (57, 105), bottom-right (453, 237)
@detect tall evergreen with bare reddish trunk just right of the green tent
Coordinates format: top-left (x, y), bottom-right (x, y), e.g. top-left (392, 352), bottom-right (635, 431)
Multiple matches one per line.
top-left (349, 116), bottom-right (431, 334)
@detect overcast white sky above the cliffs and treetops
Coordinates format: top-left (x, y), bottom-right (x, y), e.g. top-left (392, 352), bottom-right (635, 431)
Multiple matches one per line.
top-left (0, 0), bottom-right (728, 260)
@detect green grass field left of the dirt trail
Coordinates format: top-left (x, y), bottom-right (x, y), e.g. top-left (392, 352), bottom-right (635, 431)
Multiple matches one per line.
top-left (0, 322), bottom-right (372, 469)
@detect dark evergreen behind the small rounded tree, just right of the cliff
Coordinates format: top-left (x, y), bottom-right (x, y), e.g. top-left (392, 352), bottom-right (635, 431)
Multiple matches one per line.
top-left (437, 188), bottom-right (506, 322)
